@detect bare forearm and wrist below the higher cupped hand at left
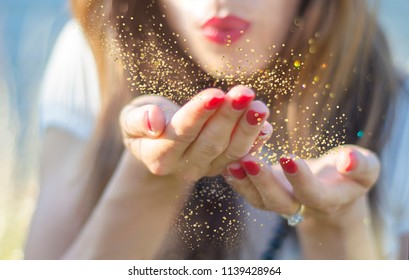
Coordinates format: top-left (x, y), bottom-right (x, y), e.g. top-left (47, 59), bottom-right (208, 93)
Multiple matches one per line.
top-left (64, 152), bottom-right (188, 259)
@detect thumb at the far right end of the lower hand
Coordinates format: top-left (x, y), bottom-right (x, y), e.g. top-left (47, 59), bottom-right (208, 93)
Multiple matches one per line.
top-left (336, 146), bottom-right (380, 188)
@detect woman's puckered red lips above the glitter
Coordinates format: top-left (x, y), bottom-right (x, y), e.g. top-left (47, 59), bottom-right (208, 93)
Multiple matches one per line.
top-left (202, 16), bottom-right (250, 45)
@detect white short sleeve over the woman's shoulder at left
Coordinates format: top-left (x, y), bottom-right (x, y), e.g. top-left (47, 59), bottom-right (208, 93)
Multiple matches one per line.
top-left (40, 20), bottom-right (100, 138)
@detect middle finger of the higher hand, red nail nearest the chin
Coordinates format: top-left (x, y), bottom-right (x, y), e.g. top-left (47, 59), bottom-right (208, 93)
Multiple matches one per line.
top-left (185, 86), bottom-right (255, 168)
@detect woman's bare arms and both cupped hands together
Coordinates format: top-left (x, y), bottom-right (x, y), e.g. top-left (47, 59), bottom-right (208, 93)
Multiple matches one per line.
top-left (26, 87), bottom-right (407, 259)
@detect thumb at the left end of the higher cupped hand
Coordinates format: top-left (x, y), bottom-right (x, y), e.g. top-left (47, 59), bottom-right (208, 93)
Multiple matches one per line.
top-left (120, 104), bottom-right (166, 138)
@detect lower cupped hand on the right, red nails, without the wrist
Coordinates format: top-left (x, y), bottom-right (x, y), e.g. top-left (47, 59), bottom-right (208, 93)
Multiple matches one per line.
top-left (225, 145), bottom-right (380, 224)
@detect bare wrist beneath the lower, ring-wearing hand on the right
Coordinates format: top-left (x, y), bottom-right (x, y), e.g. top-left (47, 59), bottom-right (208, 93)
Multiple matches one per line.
top-left (297, 197), bottom-right (379, 259)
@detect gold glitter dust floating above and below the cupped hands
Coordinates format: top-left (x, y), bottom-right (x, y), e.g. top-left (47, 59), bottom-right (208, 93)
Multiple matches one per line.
top-left (87, 2), bottom-right (354, 249)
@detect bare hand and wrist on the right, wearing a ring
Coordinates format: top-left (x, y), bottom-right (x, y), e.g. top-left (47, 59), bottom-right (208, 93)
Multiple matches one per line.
top-left (118, 88), bottom-right (380, 259)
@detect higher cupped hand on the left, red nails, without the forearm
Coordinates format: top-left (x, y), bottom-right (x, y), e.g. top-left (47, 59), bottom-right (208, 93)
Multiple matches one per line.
top-left (120, 86), bottom-right (272, 183)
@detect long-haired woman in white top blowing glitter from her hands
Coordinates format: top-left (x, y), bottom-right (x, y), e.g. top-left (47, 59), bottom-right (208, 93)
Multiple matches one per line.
top-left (26, 0), bottom-right (409, 259)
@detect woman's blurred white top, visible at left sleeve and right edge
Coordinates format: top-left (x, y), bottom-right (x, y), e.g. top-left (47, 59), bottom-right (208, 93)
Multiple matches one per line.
top-left (40, 20), bottom-right (409, 259)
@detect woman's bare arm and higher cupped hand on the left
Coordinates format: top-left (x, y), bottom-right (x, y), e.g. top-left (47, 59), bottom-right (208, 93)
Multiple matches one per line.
top-left (26, 87), bottom-right (271, 259)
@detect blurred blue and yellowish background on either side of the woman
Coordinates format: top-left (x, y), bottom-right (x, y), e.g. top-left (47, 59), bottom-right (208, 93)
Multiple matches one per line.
top-left (0, 0), bottom-right (409, 259)
